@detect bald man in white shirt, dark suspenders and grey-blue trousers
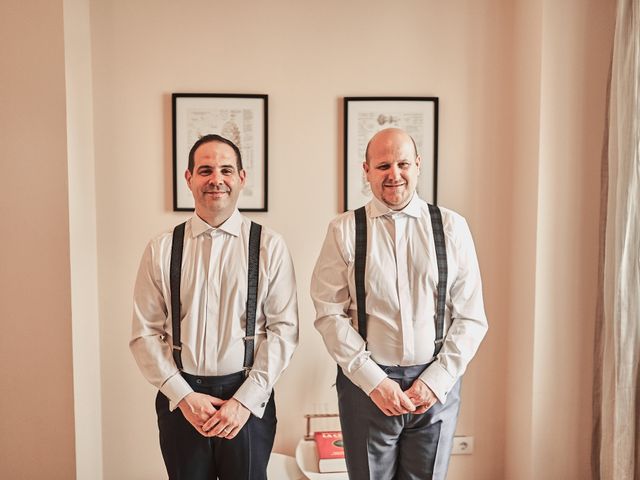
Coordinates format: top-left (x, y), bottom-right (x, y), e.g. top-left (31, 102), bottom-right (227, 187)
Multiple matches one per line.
top-left (311, 129), bottom-right (487, 480)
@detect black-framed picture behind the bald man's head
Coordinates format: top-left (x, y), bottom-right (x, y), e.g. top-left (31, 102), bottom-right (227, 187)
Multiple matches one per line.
top-left (344, 97), bottom-right (438, 211)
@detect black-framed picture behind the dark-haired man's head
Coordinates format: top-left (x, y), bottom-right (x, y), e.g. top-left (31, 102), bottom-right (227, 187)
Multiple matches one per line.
top-left (171, 93), bottom-right (268, 212)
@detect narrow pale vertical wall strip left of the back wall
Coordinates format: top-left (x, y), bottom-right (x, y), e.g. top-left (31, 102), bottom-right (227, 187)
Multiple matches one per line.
top-left (63, 0), bottom-right (103, 480)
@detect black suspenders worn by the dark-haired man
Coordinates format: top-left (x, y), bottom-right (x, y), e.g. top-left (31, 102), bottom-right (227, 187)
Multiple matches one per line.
top-left (169, 222), bottom-right (262, 375)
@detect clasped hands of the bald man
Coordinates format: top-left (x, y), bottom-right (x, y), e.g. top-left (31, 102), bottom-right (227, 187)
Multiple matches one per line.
top-left (369, 377), bottom-right (438, 416)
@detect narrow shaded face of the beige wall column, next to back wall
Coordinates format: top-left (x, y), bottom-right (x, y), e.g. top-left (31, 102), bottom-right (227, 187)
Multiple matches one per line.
top-left (504, 0), bottom-right (544, 479)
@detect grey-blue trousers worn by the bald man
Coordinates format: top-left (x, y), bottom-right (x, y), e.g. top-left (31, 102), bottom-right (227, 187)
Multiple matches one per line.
top-left (336, 365), bottom-right (460, 480)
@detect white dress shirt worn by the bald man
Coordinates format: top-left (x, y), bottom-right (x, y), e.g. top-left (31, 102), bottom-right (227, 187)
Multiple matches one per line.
top-left (311, 194), bottom-right (487, 403)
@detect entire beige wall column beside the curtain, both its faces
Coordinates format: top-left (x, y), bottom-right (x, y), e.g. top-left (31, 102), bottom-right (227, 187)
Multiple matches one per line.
top-left (506, 0), bottom-right (614, 479)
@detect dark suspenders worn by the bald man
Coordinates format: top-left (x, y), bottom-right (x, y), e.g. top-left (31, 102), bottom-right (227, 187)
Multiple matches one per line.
top-left (354, 204), bottom-right (448, 357)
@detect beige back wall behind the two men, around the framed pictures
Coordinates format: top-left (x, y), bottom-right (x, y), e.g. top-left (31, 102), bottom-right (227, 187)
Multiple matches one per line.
top-left (92, 1), bottom-right (513, 479)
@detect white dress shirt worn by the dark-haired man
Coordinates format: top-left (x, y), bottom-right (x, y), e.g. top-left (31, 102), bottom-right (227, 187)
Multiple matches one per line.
top-left (130, 210), bottom-right (298, 417)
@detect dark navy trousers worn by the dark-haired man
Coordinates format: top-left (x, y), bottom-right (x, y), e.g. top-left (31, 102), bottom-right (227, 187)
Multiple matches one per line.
top-left (156, 372), bottom-right (276, 480)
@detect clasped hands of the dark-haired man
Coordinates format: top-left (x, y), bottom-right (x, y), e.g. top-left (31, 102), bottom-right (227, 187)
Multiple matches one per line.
top-left (178, 392), bottom-right (251, 440)
